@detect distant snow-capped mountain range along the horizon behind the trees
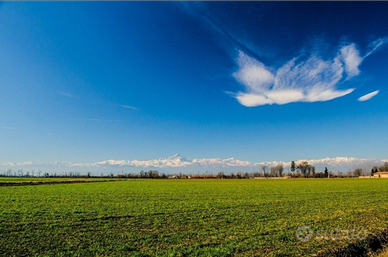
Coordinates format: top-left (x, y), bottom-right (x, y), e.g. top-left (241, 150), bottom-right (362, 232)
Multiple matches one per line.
top-left (0, 154), bottom-right (388, 173)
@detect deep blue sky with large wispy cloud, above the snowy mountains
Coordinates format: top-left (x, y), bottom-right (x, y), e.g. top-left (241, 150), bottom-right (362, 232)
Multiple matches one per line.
top-left (0, 1), bottom-right (388, 166)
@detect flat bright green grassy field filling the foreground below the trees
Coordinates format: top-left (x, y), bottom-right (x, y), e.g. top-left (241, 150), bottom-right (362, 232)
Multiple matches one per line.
top-left (0, 179), bottom-right (388, 256)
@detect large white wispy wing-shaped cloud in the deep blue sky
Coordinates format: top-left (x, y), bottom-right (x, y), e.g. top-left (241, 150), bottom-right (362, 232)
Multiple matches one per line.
top-left (233, 39), bottom-right (387, 107)
